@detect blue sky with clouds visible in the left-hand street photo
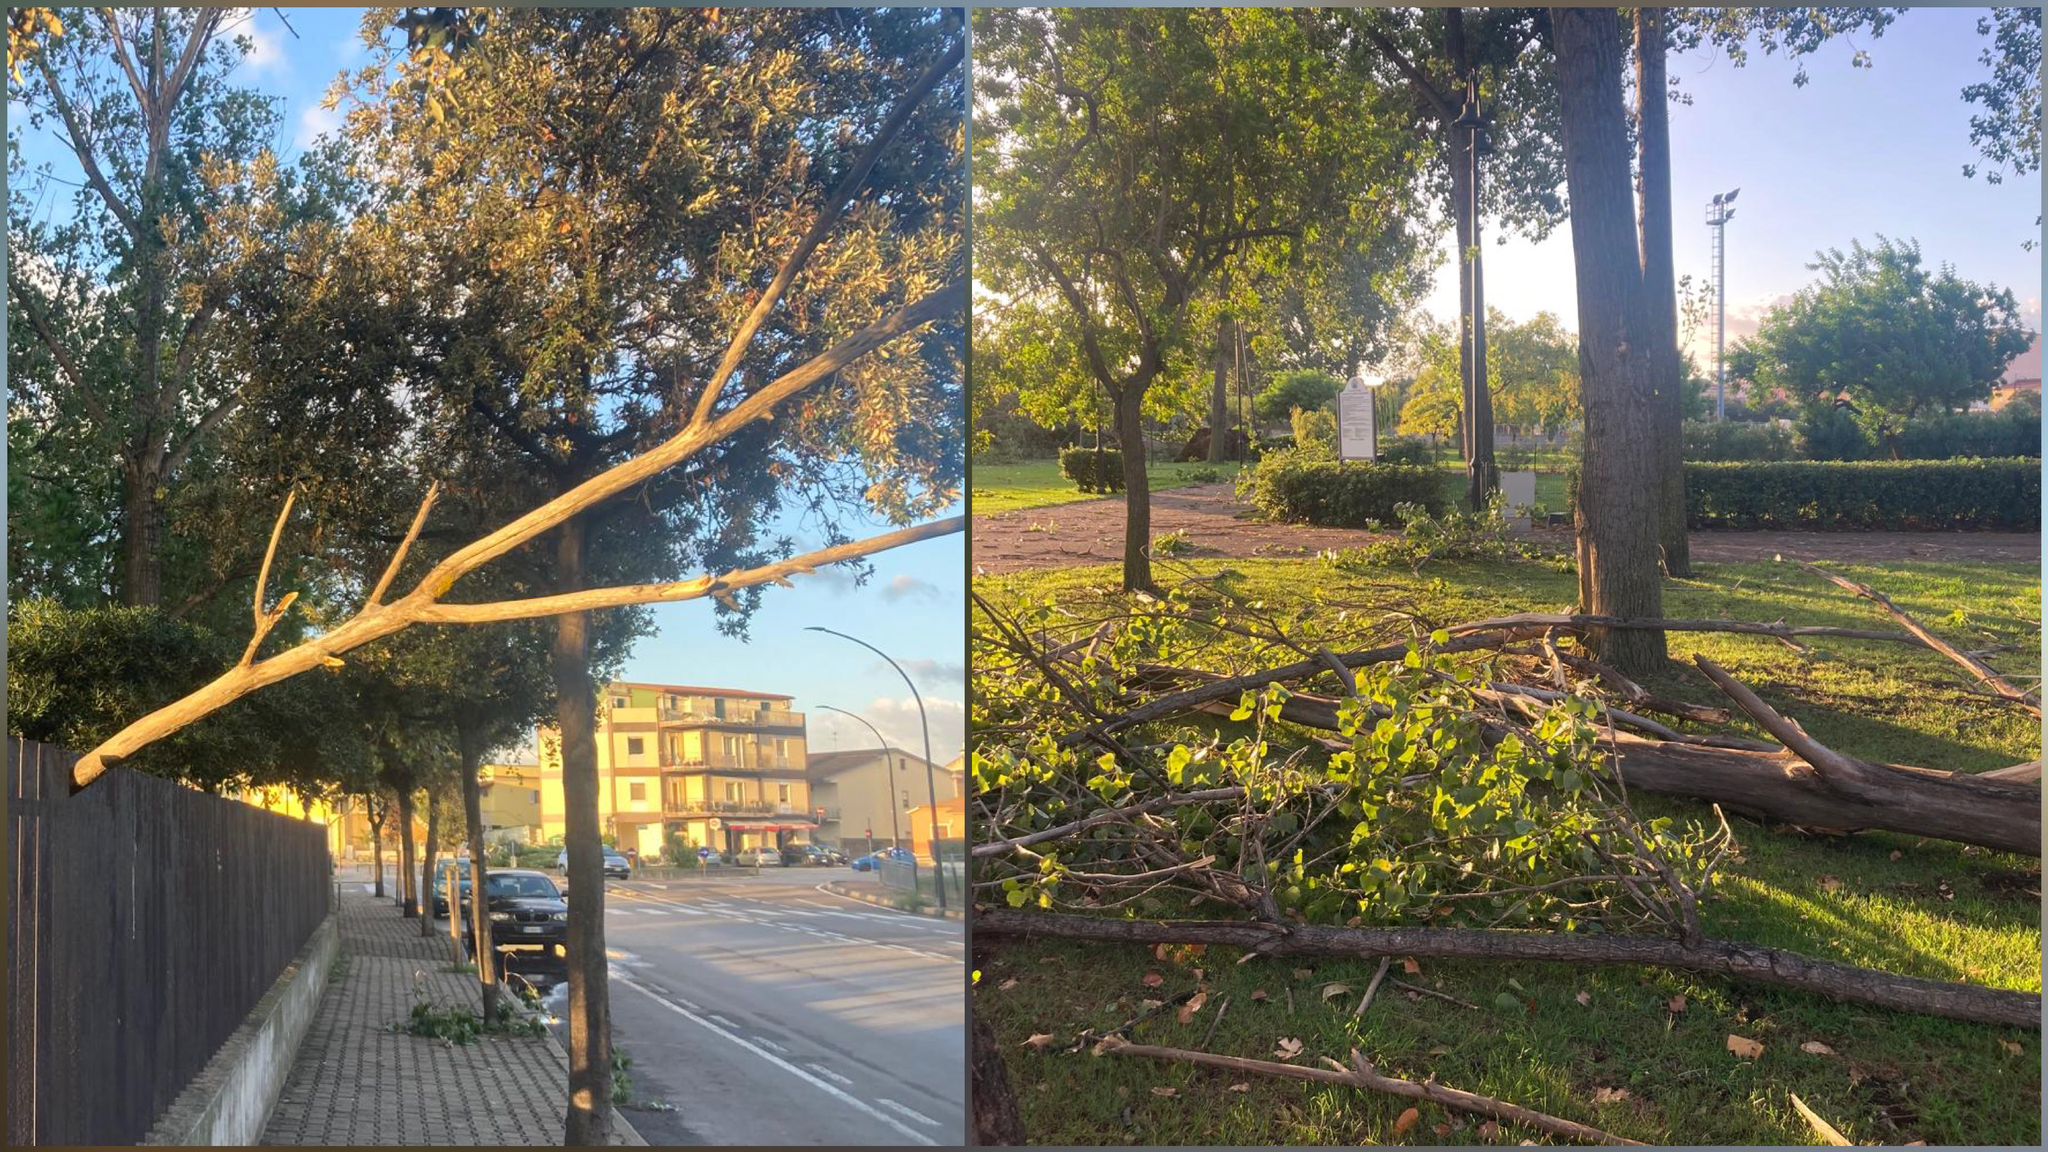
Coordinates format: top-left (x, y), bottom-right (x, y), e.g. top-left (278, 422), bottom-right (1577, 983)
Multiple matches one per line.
top-left (8, 8), bottom-right (967, 763)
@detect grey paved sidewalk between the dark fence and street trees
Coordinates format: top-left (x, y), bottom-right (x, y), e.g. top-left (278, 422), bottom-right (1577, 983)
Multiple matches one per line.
top-left (262, 875), bottom-right (641, 1146)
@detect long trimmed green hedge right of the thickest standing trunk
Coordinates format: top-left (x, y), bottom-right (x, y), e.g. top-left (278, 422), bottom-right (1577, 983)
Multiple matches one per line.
top-left (1686, 459), bottom-right (2042, 531)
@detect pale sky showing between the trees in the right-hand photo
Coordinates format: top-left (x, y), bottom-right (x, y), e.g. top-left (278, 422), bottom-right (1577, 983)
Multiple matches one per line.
top-left (1425, 8), bottom-right (2042, 367)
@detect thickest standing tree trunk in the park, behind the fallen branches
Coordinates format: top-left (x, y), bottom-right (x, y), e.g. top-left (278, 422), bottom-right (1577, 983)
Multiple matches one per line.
top-left (1550, 8), bottom-right (1665, 674)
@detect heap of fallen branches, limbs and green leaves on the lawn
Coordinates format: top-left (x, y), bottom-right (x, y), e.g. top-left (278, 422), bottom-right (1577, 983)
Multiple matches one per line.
top-left (973, 572), bottom-right (2040, 1027)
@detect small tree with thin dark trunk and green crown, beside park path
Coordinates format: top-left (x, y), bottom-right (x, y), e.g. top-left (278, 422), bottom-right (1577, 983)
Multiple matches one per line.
top-left (975, 8), bottom-right (1415, 588)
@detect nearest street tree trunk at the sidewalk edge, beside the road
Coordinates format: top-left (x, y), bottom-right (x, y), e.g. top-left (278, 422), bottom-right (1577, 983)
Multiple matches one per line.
top-left (552, 519), bottom-right (612, 1146)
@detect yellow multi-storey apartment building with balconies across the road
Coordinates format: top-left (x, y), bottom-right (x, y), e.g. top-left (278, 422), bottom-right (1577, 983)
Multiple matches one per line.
top-left (539, 683), bottom-right (817, 861)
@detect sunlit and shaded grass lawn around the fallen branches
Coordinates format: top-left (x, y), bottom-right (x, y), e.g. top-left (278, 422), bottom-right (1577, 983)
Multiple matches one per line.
top-left (975, 562), bottom-right (2042, 1146)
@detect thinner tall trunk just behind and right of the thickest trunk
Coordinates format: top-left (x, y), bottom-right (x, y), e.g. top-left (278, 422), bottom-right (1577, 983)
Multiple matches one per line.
top-left (1634, 8), bottom-right (1692, 576)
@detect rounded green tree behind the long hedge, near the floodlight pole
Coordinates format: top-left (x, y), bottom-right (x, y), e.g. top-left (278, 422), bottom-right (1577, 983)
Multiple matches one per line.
top-left (1747, 236), bottom-right (2032, 432)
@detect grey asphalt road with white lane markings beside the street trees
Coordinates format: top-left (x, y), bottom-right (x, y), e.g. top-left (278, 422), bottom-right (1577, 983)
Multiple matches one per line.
top-left (551, 867), bottom-right (967, 1146)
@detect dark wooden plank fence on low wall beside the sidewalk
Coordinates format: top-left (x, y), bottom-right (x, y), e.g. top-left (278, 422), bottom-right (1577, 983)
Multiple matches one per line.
top-left (6, 738), bottom-right (332, 1146)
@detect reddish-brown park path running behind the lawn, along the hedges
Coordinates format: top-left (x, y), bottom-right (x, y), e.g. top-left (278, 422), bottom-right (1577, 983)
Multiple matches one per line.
top-left (973, 484), bottom-right (2042, 576)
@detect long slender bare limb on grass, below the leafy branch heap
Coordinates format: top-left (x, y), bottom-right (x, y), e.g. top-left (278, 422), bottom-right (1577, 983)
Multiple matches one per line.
top-left (973, 908), bottom-right (2042, 1029)
